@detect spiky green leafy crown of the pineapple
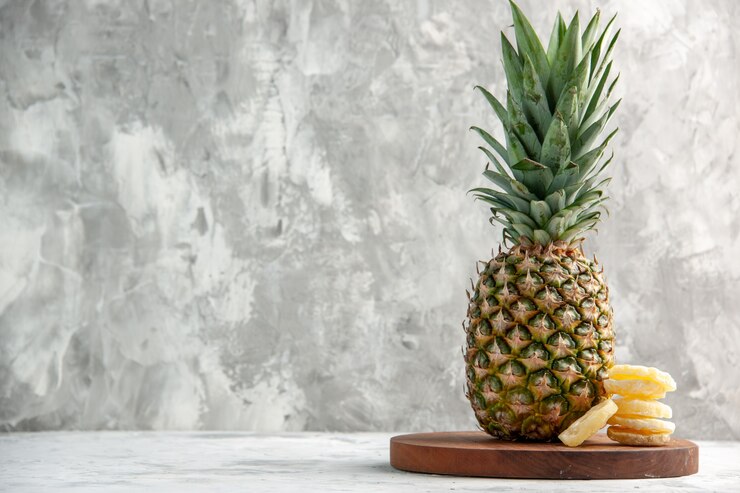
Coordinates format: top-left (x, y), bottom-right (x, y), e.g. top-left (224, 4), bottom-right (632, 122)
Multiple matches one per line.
top-left (471, 1), bottom-right (621, 245)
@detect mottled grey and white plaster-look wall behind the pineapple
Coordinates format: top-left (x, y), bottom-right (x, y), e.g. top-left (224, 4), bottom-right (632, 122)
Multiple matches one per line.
top-left (0, 0), bottom-right (740, 439)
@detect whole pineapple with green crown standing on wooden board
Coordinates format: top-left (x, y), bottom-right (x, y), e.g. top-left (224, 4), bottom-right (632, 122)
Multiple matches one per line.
top-left (464, 2), bottom-right (619, 440)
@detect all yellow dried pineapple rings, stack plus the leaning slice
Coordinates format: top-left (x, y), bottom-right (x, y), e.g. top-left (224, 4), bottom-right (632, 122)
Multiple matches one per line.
top-left (558, 365), bottom-right (676, 447)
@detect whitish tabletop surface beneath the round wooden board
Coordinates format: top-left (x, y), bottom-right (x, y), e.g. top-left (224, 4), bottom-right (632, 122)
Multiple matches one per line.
top-left (0, 432), bottom-right (740, 493)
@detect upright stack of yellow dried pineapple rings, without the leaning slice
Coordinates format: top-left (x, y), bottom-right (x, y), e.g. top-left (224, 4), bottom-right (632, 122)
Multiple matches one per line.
top-left (604, 365), bottom-right (676, 446)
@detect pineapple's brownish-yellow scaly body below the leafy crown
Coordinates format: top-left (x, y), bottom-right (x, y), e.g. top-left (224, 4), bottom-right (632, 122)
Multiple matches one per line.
top-left (463, 242), bottom-right (614, 441)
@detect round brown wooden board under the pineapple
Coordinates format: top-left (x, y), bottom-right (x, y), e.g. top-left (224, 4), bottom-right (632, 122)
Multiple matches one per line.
top-left (391, 431), bottom-right (699, 479)
